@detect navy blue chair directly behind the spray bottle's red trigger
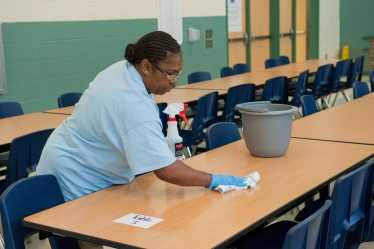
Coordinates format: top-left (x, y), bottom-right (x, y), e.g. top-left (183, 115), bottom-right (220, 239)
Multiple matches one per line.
top-left (179, 92), bottom-right (218, 148)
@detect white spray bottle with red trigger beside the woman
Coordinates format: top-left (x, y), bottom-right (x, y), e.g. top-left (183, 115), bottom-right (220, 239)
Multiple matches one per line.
top-left (164, 103), bottom-right (188, 160)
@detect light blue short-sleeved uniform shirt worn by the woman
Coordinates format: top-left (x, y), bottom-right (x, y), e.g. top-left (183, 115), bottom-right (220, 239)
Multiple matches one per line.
top-left (36, 61), bottom-right (175, 200)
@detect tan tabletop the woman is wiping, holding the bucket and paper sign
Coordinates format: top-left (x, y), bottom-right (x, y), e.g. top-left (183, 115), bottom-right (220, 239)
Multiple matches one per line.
top-left (24, 139), bottom-right (374, 249)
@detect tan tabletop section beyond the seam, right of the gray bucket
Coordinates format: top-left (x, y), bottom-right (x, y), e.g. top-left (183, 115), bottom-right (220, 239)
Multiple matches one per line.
top-left (292, 94), bottom-right (374, 145)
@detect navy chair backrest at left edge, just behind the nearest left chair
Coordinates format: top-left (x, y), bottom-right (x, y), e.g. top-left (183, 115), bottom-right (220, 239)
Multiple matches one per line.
top-left (0, 129), bottom-right (53, 191)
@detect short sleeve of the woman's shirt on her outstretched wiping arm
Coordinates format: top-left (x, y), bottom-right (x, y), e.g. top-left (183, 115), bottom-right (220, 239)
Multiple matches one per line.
top-left (124, 121), bottom-right (176, 175)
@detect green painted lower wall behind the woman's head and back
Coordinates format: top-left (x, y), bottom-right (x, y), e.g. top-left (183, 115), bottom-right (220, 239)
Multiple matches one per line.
top-left (0, 16), bottom-right (227, 112)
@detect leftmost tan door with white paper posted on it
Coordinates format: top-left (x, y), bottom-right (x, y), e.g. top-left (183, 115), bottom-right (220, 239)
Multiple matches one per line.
top-left (227, 0), bottom-right (248, 66)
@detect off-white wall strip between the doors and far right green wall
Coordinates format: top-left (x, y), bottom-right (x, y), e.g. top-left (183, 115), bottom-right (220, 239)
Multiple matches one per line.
top-left (319, 0), bottom-right (340, 59)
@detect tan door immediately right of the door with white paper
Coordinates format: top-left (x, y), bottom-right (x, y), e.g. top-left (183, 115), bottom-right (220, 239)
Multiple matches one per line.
top-left (250, 0), bottom-right (271, 71)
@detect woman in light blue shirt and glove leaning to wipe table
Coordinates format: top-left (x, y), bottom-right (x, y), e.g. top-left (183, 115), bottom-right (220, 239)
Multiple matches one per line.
top-left (37, 31), bottom-right (245, 208)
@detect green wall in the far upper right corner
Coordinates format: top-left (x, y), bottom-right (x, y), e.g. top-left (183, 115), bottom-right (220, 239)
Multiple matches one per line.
top-left (340, 0), bottom-right (374, 71)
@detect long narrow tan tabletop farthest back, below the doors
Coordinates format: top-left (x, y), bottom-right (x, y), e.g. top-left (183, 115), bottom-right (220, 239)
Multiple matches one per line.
top-left (177, 60), bottom-right (336, 91)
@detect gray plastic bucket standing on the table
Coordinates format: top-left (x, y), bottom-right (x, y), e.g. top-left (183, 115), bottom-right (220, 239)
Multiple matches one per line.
top-left (236, 101), bottom-right (294, 157)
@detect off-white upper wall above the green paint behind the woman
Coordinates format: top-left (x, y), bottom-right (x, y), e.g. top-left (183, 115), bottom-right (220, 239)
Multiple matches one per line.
top-left (0, 0), bottom-right (226, 22)
